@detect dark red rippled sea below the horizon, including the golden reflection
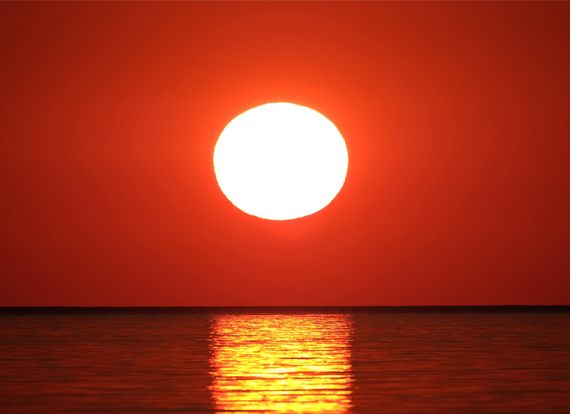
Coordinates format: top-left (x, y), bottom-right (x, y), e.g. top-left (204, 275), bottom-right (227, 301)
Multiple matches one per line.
top-left (0, 308), bottom-right (570, 414)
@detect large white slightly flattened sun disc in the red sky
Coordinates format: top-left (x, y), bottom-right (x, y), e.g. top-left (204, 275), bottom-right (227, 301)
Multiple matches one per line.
top-left (214, 103), bottom-right (348, 220)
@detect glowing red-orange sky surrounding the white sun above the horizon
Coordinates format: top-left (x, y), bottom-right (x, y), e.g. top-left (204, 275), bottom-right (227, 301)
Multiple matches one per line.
top-left (0, 2), bottom-right (570, 306)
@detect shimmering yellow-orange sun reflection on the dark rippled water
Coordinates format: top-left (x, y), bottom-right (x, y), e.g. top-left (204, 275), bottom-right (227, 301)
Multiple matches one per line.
top-left (210, 315), bottom-right (353, 413)
